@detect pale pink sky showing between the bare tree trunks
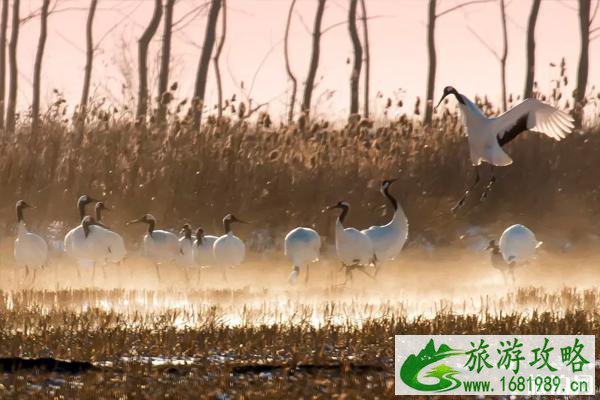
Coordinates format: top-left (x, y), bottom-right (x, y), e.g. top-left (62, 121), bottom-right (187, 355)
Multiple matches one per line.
top-left (10, 0), bottom-right (600, 117)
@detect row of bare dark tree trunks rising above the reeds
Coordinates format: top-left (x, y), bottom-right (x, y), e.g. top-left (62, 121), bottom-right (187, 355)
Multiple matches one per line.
top-left (0, 0), bottom-right (600, 135)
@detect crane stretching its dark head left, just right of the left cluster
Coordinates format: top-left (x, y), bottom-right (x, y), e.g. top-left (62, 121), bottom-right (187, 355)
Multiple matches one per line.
top-left (127, 214), bottom-right (182, 281)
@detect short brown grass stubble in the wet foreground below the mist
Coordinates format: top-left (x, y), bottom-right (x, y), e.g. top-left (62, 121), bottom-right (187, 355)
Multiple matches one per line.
top-left (0, 288), bottom-right (600, 398)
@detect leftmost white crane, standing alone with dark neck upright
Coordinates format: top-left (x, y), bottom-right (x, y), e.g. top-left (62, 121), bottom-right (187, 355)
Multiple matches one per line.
top-left (14, 200), bottom-right (48, 283)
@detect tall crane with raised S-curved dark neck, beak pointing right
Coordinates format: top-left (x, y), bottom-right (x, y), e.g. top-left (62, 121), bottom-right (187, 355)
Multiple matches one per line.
top-left (362, 179), bottom-right (408, 273)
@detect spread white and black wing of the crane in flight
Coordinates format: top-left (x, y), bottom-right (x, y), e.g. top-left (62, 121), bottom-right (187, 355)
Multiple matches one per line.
top-left (493, 99), bottom-right (575, 146)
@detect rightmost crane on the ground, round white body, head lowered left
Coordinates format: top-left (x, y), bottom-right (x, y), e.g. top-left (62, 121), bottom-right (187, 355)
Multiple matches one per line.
top-left (487, 224), bottom-right (542, 283)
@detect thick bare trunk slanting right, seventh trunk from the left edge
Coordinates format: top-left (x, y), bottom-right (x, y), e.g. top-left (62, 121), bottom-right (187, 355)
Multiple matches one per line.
top-left (194, 0), bottom-right (221, 128)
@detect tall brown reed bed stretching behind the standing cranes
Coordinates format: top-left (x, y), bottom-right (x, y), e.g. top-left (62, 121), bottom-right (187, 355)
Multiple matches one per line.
top-left (0, 87), bottom-right (600, 245)
